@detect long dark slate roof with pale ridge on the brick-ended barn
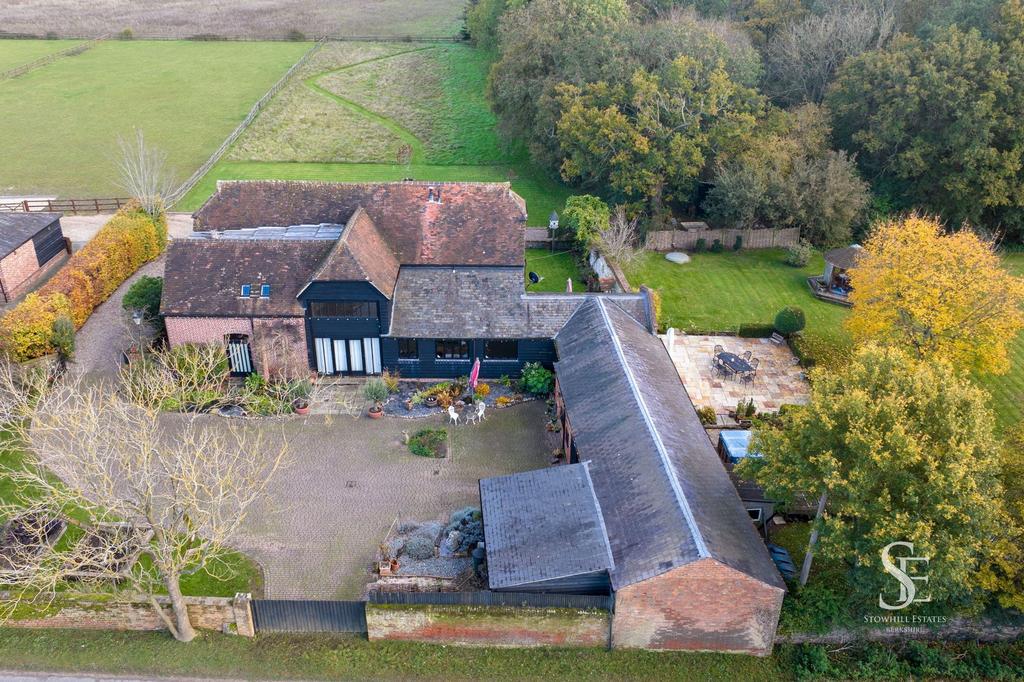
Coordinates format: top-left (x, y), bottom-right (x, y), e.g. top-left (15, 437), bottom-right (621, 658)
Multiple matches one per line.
top-left (555, 299), bottom-right (784, 590)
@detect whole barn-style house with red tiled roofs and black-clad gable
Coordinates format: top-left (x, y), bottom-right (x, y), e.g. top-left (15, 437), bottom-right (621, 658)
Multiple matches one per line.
top-left (162, 181), bottom-right (652, 378)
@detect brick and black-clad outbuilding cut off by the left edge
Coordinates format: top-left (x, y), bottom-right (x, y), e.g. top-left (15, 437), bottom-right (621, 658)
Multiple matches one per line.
top-left (0, 212), bottom-right (71, 303)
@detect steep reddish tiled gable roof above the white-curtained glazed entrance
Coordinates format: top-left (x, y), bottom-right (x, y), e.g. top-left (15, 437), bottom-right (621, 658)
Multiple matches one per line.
top-left (312, 207), bottom-right (398, 298)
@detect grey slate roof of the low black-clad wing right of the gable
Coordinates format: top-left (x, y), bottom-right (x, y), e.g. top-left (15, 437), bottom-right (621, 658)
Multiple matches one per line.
top-left (388, 266), bottom-right (649, 339)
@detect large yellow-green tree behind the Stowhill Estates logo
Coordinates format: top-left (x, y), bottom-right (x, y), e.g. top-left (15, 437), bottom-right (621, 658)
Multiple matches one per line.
top-left (741, 344), bottom-right (1001, 603)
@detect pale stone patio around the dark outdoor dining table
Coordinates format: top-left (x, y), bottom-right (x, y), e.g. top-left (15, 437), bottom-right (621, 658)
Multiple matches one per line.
top-left (662, 332), bottom-right (810, 415)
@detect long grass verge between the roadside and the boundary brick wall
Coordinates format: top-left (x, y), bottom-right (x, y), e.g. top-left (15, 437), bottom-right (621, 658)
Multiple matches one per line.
top-left (0, 630), bottom-right (794, 682)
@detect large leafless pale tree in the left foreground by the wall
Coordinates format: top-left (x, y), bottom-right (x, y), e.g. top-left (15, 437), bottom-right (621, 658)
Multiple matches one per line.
top-left (0, 368), bottom-right (288, 642)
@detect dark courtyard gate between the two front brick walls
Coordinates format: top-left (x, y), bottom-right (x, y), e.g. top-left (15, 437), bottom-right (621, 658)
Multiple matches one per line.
top-left (252, 599), bottom-right (367, 635)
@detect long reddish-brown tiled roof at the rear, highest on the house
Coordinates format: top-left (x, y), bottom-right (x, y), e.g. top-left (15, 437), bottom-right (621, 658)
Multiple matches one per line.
top-left (194, 180), bottom-right (526, 266)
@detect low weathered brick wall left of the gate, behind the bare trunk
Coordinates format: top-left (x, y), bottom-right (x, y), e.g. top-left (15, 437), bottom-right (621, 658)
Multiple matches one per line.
top-left (4, 594), bottom-right (255, 637)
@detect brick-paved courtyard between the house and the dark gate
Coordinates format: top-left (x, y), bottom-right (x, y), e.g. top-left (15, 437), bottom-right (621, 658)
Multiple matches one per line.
top-left (223, 400), bottom-right (552, 599)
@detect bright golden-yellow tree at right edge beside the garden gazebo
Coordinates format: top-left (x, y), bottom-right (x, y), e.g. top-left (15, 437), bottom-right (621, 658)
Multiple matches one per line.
top-left (847, 216), bottom-right (1024, 374)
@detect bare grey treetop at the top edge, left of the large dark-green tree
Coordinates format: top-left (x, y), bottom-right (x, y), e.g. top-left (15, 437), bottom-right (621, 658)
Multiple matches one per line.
top-left (765, 0), bottom-right (896, 103)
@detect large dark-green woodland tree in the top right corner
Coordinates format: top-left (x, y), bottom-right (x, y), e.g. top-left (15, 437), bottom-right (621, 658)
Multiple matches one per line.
top-left (826, 0), bottom-right (1024, 236)
